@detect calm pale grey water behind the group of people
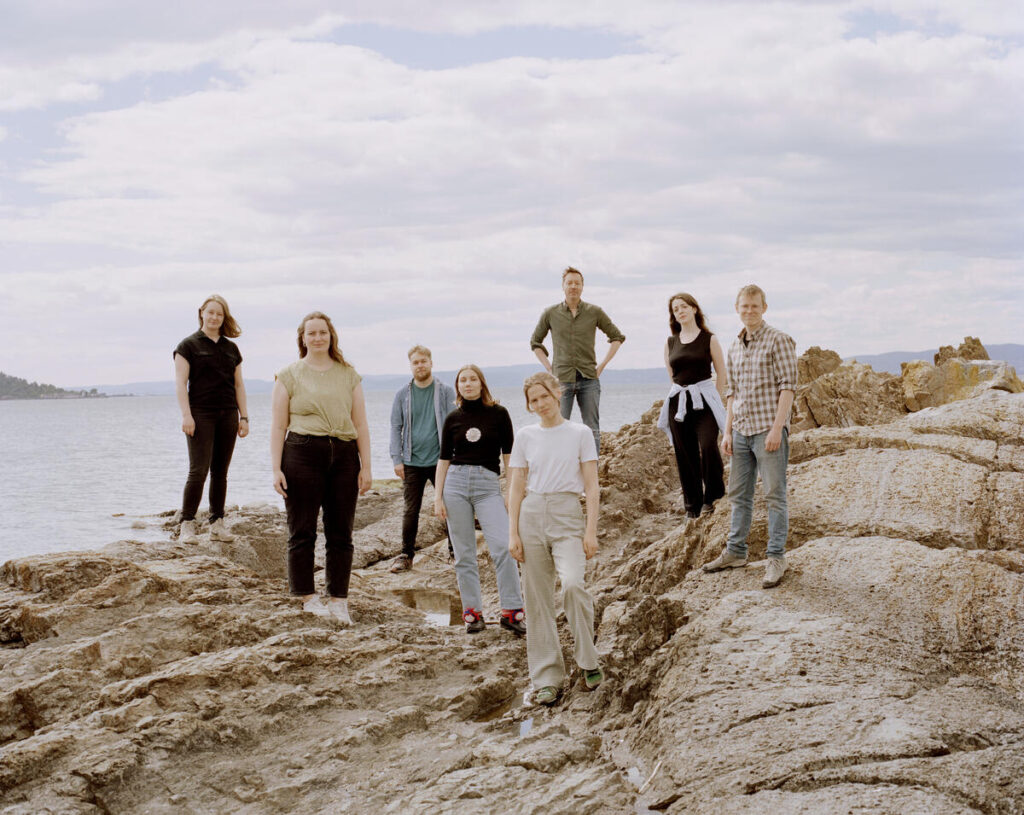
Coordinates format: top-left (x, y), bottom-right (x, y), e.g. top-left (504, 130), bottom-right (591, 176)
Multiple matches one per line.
top-left (0, 385), bottom-right (668, 563)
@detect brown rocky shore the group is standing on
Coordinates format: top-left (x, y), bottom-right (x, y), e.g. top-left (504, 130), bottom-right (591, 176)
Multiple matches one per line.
top-left (0, 344), bottom-right (1024, 815)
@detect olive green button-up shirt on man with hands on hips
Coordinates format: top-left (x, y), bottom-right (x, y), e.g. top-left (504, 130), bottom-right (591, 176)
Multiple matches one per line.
top-left (529, 300), bottom-right (626, 382)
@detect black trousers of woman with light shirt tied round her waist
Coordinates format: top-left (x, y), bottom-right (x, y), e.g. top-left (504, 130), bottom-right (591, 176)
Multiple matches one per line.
top-left (669, 393), bottom-right (725, 515)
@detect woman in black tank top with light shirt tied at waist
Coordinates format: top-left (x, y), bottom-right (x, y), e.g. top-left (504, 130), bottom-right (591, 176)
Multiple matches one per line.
top-left (665, 293), bottom-right (726, 518)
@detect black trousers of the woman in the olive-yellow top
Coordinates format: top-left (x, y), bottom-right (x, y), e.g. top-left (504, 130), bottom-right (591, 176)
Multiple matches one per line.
top-left (281, 433), bottom-right (359, 597)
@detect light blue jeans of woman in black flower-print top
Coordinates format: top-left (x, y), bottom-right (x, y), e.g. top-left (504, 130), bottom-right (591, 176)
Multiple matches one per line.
top-left (444, 464), bottom-right (522, 612)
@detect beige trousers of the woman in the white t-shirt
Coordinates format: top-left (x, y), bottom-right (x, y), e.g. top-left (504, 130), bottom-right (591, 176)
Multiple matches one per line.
top-left (519, 492), bottom-right (598, 688)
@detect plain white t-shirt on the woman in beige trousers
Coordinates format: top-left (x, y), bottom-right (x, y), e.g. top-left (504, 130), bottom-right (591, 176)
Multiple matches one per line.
top-left (509, 422), bottom-right (597, 495)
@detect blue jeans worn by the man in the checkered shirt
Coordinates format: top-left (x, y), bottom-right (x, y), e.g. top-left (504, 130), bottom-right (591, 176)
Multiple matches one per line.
top-left (726, 428), bottom-right (790, 557)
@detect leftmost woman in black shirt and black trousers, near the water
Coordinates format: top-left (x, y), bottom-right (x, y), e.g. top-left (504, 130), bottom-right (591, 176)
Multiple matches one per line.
top-left (174, 294), bottom-right (249, 544)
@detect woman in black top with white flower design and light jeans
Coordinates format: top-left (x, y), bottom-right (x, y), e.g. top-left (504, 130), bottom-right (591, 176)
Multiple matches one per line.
top-left (434, 364), bottom-right (526, 635)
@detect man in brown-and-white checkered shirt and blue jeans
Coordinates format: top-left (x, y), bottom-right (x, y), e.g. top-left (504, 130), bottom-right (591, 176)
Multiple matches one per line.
top-left (703, 285), bottom-right (797, 589)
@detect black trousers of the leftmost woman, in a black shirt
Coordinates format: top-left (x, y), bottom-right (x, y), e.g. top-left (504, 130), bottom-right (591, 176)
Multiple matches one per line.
top-left (181, 408), bottom-right (239, 523)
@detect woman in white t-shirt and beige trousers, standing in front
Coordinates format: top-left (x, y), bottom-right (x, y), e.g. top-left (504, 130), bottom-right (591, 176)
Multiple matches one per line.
top-left (509, 373), bottom-right (604, 704)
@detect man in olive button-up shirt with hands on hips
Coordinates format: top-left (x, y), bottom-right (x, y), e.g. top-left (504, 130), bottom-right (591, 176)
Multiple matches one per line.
top-left (529, 266), bottom-right (626, 453)
